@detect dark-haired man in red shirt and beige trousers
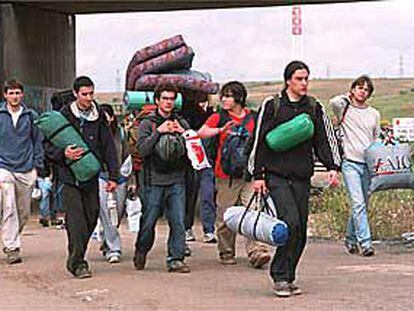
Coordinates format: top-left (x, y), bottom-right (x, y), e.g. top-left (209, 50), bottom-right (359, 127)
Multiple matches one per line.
top-left (198, 81), bottom-right (270, 268)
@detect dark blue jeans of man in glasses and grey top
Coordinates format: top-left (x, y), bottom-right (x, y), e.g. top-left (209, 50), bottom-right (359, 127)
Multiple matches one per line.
top-left (135, 183), bottom-right (185, 265)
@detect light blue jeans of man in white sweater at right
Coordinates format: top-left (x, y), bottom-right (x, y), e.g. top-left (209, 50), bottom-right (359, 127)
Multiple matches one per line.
top-left (342, 160), bottom-right (372, 249)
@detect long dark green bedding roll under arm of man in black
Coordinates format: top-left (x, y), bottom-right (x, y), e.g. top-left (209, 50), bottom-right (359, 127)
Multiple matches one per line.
top-left (35, 111), bottom-right (101, 182)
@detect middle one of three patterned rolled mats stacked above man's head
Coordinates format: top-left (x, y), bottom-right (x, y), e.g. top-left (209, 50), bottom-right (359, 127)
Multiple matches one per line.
top-left (126, 46), bottom-right (194, 91)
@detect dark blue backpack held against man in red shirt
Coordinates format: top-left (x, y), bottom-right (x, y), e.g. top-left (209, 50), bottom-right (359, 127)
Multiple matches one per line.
top-left (219, 113), bottom-right (254, 178)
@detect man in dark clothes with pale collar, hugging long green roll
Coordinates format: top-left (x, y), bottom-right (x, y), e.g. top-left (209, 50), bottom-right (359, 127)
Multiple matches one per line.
top-left (46, 76), bottom-right (119, 279)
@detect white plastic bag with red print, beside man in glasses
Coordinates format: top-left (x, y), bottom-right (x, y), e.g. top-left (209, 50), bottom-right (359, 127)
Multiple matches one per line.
top-left (183, 130), bottom-right (211, 171)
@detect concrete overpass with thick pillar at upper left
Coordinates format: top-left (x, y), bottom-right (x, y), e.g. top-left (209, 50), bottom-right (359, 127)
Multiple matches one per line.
top-left (0, 0), bottom-right (372, 110)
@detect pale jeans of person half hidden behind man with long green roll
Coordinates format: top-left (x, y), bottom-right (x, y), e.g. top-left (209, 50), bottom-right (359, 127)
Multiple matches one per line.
top-left (99, 178), bottom-right (127, 258)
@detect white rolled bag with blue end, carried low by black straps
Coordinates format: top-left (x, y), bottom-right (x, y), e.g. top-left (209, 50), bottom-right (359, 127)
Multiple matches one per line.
top-left (223, 206), bottom-right (289, 246)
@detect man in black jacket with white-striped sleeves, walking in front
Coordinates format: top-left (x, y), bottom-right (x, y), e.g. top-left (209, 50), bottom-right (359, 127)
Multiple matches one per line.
top-left (249, 61), bottom-right (340, 297)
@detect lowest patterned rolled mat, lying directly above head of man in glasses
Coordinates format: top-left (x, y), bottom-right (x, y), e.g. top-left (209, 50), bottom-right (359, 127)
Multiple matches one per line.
top-left (134, 74), bottom-right (219, 94)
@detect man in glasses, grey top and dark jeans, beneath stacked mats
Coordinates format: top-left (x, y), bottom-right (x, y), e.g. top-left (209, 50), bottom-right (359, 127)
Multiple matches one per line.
top-left (134, 84), bottom-right (190, 273)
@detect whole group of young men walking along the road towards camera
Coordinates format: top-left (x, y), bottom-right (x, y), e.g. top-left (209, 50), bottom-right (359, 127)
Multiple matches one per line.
top-left (0, 61), bottom-right (380, 297)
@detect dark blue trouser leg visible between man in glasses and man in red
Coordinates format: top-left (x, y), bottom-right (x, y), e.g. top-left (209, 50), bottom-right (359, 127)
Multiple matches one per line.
top-left (199, 168), bottom-right (216, 233)
